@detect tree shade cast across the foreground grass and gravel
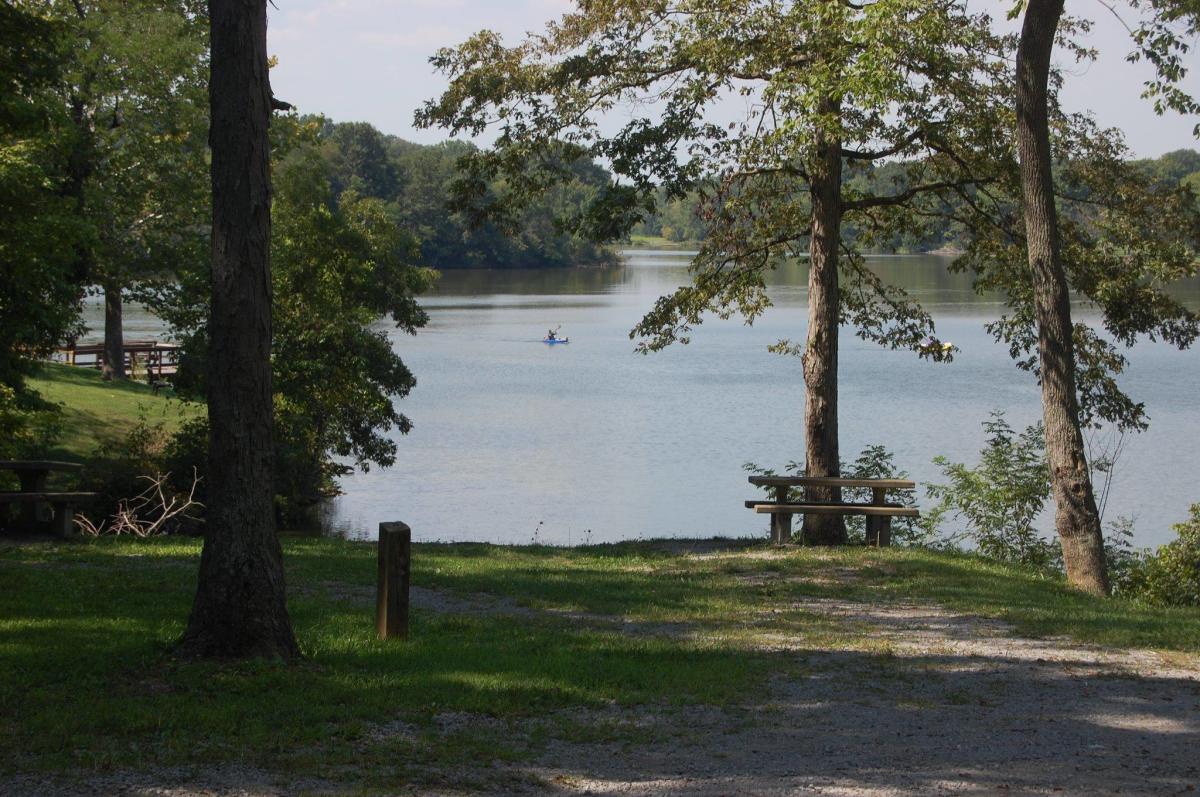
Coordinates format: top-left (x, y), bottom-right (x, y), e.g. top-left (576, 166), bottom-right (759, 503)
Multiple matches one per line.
top-left (0, 543), bottom-right (1200, 793)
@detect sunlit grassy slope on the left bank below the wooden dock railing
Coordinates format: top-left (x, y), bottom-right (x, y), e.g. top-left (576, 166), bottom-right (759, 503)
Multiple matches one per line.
top-left (29, 362), bottom-right (204, 462)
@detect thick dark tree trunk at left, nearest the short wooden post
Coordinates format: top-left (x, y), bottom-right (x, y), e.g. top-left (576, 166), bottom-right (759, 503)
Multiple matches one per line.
top-left (180, 0), bottom-right (299, 658)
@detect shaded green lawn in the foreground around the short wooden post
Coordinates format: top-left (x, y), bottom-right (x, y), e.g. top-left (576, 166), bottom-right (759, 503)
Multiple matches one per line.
top-left (0, 537), bottom-right (1200, 790)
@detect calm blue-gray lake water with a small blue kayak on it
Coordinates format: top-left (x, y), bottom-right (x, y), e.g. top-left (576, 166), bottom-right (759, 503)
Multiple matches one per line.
top-left (79, 250), bottom-right (1200, 545)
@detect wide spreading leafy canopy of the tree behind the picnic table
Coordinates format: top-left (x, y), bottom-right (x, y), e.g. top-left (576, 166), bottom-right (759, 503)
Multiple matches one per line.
top-left (418, 0), bottom-right (1009, 359)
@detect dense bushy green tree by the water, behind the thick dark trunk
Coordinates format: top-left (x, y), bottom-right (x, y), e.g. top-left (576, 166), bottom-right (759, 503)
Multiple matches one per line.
top-left (156, 118), bottom-right (436, 514)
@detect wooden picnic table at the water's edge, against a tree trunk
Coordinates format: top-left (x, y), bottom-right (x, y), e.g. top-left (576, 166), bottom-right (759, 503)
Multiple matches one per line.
top-left (745, 477), bottom-right (920, 546)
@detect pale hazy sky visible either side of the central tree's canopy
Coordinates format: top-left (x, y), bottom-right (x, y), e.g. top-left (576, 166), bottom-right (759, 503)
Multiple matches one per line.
top-left (268, 0), bottom-right (1200, 157)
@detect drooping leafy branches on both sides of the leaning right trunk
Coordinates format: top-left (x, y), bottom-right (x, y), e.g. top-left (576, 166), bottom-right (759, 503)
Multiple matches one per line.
top-left (953, 122), bottom-right (1200, 430)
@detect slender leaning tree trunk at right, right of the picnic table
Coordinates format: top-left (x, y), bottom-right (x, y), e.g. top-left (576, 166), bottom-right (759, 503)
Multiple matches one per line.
top-left (1016, 0), bottom-right (1109, 594)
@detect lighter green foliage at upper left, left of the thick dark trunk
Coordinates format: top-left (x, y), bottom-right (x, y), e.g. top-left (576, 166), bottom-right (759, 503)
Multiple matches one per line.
top-left (46, 0), bottom-right (209, 302)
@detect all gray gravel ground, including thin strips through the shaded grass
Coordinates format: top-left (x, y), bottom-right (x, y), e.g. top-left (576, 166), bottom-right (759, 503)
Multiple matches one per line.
top-left (11, 576), bottom-right (1200, 797)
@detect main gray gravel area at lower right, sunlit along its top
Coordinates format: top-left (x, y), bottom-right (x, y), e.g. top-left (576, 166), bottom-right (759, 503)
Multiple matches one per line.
top-left (523, 601), bottom-right (1200, 797)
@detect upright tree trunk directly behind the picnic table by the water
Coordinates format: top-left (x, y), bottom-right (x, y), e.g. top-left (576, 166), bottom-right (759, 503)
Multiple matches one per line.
top-left (804, 102), bottom-right (846, 545)
